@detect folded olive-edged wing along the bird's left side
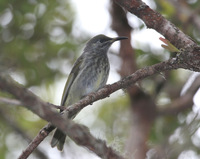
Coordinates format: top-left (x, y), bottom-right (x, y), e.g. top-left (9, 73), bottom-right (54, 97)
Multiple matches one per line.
top-left (61, 56), bottom-right (84, 106)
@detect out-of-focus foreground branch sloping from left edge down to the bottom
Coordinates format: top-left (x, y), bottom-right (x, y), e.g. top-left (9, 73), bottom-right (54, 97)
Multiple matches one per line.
top-left (0, 75), bottom-right (123, 159)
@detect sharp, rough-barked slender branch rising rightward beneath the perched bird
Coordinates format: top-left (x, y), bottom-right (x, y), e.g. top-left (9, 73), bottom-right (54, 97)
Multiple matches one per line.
top-left (66, 59), bottom-right (182, 116)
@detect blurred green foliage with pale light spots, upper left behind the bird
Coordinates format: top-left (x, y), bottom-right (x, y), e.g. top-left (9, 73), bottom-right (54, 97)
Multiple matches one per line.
top-left (0, 0), bottom-right (82, 87)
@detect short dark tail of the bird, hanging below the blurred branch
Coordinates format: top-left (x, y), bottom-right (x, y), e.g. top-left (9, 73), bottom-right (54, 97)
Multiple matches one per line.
top-left (51, 129), bottom-right (66, 151)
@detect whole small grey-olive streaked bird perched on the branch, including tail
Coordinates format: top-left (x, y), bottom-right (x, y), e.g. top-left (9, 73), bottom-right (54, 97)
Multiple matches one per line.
top-left (51, 34), bottom-right (127, 151)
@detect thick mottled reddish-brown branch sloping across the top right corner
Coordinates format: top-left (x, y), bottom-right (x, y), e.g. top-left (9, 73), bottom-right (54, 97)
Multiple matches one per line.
top-left (114, 0), bottom-right (200, 72)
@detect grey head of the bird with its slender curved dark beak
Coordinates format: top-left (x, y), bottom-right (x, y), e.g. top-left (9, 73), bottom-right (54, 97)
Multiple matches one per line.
top-left (84, 34), bottom-right (128, 53)
